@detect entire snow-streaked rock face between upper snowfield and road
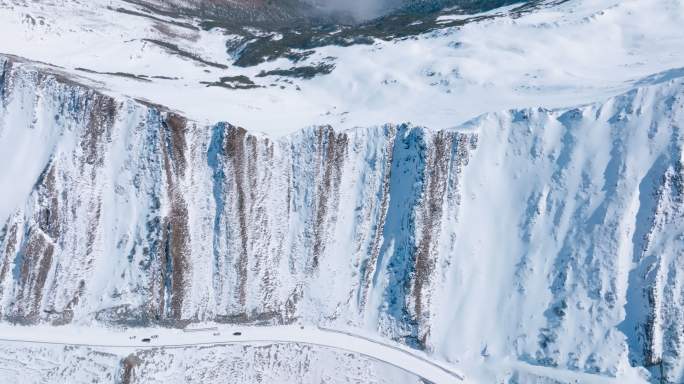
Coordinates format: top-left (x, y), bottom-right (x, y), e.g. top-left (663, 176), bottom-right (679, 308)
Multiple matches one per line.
top-left (0, 54), bottom-right (684, 381)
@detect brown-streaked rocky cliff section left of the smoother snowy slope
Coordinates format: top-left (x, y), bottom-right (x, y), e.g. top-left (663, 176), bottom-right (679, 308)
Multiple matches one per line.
top-left (0, 55), bottom-right (476, 342)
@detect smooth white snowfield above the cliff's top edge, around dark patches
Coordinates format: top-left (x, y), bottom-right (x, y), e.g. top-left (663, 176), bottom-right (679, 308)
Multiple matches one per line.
top-left (0, 0), bottom-right (684, 136)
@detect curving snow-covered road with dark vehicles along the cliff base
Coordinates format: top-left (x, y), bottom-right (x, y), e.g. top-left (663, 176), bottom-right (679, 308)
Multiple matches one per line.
top-left (0, 325), bottom-right (464, 384)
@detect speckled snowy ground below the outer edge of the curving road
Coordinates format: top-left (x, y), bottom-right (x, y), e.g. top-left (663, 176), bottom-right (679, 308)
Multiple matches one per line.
top-left (0, 332), bottom-right (422, 384)
